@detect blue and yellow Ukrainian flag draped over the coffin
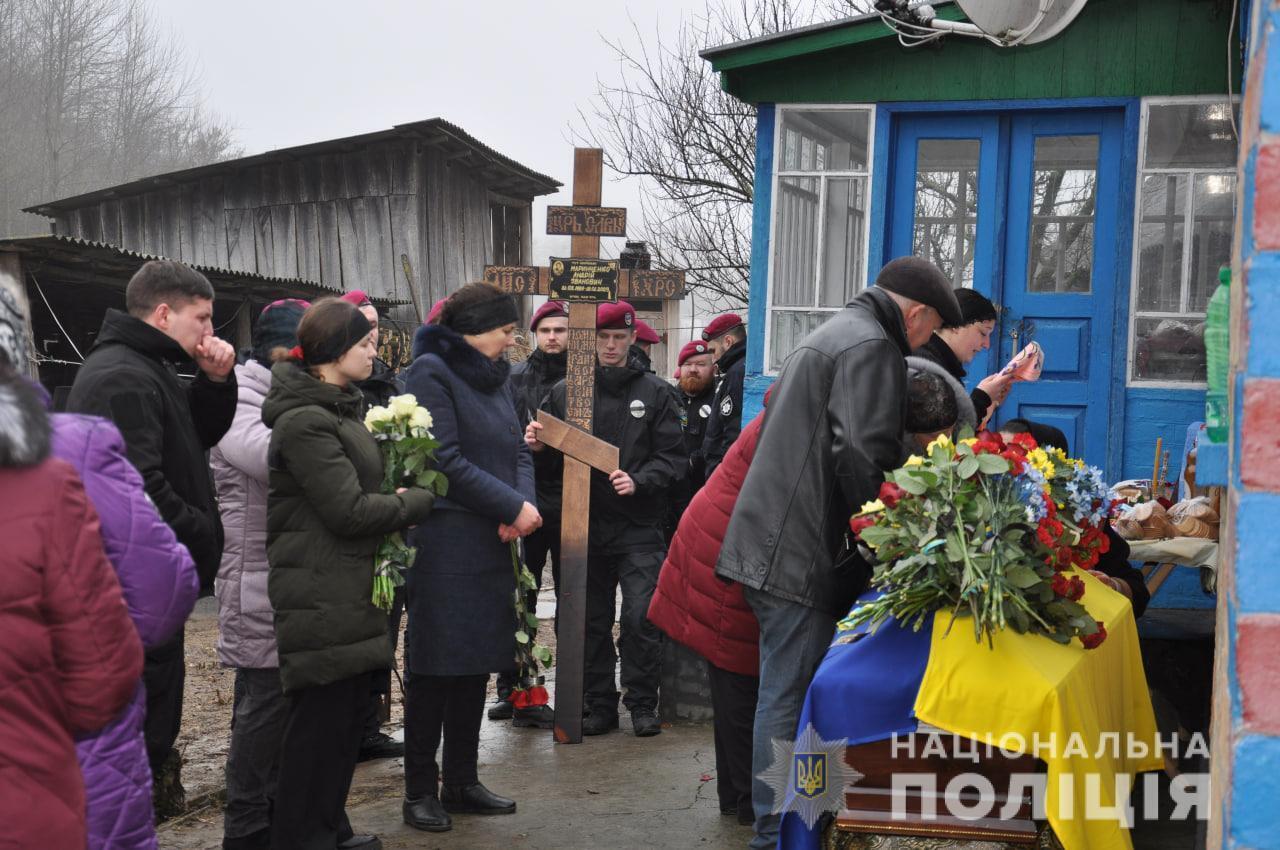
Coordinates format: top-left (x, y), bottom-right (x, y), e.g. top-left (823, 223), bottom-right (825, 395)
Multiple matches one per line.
top-left (780, 573), bottom-right (1164, 850)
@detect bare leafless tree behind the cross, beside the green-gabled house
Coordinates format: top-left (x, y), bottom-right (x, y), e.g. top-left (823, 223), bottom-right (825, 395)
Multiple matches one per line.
top-left (572, 0), bottom-right (867, 307)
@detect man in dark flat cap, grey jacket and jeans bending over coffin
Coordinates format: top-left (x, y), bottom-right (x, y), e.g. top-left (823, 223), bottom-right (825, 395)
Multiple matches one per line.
top-left (716, 257), bottom-right (960, 850)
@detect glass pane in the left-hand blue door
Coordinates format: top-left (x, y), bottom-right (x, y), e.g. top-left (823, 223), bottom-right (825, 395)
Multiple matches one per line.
top-left (911, 138), bottom-right (982, 287)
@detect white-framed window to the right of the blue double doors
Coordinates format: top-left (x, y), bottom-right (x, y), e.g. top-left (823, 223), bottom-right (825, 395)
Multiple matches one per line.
top-left (1129, 97), bottom-right (1236, 384)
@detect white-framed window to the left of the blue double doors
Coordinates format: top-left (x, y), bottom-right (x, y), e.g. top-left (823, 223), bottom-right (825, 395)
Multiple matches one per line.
top-left (765, 106), bottom-right (872, 373)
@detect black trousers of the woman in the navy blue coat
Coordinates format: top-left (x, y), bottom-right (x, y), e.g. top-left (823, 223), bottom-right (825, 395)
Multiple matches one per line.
top-left (404, 671), bottom-right (489, 799)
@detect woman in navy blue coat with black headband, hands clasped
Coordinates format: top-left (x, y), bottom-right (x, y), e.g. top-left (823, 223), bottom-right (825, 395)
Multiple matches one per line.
top-left (404, 283), bottom-right (541, 832)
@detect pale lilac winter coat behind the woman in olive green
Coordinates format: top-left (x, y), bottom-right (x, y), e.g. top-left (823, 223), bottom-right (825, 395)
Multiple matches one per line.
top-left (209, 360), bottom-right (280, 670)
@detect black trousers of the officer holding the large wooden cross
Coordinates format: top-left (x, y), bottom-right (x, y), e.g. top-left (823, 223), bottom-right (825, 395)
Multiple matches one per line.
top-left (582, 549), bottom-right (666, 712)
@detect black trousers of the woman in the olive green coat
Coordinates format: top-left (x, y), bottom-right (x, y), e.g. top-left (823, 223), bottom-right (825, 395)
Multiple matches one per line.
top-left (271, 673), bottom-right (374, 850)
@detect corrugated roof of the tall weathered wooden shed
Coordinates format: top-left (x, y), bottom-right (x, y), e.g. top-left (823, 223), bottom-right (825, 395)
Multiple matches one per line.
top-left (23, 118), bottom-right (561, 218)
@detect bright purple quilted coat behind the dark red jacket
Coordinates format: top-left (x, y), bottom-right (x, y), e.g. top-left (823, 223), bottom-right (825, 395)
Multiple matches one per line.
top-left (51, 413), bottom-right (200, 850)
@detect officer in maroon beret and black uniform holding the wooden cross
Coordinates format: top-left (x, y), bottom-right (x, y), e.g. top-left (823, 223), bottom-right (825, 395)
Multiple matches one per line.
top-left (525, 301), bottom-right (689, 737)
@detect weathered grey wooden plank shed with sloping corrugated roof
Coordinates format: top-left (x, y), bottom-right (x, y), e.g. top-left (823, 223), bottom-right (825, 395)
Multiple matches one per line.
top-left (26, 118), bottom-right (559, 319)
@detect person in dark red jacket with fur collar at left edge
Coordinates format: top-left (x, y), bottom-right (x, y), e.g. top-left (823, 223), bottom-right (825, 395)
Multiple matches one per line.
top-left (0, 358), bottom-right (142, 847)
